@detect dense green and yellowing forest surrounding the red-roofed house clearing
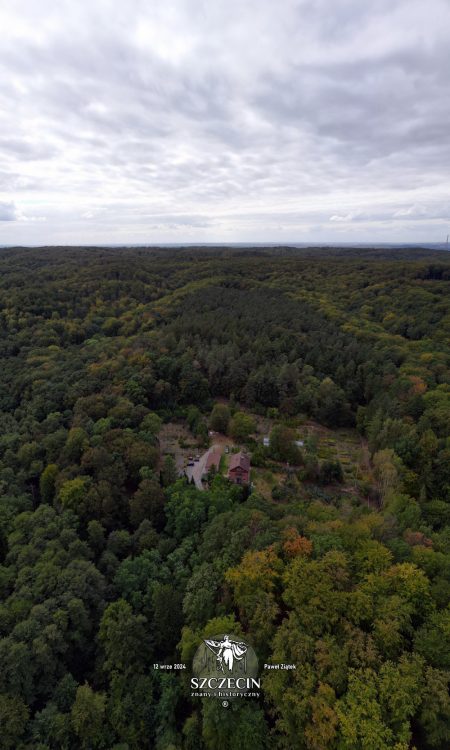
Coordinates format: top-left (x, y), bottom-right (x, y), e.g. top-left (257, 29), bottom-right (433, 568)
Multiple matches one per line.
top-left (0, 247), bottom-right (450, 750)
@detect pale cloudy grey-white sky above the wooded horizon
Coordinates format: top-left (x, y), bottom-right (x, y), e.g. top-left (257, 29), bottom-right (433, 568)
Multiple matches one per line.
top-left (0, 0), bottom-right (450, 245)
